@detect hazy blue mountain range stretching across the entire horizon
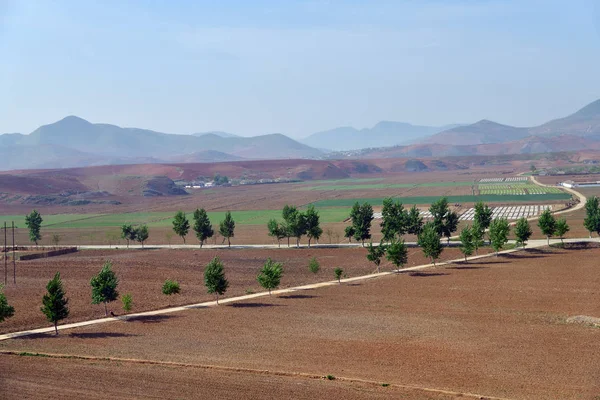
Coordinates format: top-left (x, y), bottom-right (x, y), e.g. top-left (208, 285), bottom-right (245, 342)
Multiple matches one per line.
top-left (0, 100), bottom-right (600, 170)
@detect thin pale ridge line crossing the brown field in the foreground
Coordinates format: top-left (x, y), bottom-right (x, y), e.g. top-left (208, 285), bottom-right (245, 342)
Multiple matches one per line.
top-left (0, 350), bottom-right (511, 400)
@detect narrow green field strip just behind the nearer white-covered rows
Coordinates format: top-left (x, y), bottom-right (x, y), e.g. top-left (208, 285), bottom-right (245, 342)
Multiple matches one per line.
top-left (313, 193), bottom-right (571, 208)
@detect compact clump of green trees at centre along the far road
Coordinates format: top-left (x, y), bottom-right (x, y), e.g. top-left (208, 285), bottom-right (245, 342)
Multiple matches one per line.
top-left (267, 204), bottom-right (323, 247)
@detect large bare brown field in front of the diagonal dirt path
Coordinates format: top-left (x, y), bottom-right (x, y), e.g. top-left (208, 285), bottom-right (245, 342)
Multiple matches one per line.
top-left (0, 246), bottom-right (600, 399)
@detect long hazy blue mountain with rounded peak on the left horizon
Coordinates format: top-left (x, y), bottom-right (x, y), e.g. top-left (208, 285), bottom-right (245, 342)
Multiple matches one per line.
top-left (0, 116), bottom-right (322, 169)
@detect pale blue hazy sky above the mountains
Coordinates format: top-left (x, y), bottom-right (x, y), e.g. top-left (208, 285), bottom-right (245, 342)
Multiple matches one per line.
top-left (0, 0), bottom-right (600, 138)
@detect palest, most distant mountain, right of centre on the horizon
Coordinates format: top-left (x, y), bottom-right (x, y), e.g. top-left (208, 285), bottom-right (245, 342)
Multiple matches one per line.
top-left (301, 121), bottom-right (457, 150)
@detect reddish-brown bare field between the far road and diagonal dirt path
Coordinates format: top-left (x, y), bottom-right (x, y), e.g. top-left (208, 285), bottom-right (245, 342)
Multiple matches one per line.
top-left (0, 247), bottom-right (478, 333)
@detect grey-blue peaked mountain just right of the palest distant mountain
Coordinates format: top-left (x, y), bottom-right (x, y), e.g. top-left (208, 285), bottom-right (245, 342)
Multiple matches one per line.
top-left (421, 119), bottom-right (529, 145)
